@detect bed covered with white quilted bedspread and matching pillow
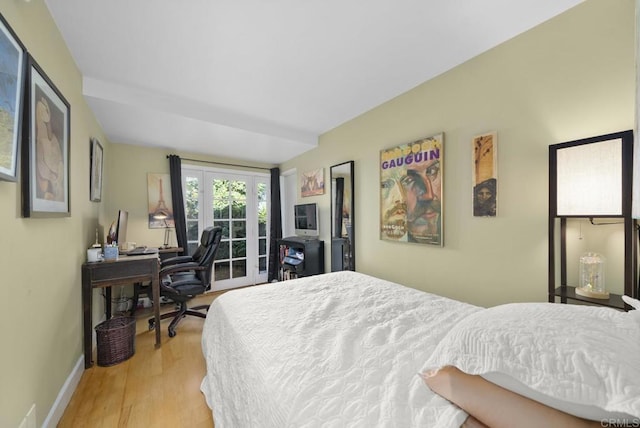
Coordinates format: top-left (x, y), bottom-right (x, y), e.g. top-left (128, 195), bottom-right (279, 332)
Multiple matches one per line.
top-left (201, 272), bottom-right (640, 428)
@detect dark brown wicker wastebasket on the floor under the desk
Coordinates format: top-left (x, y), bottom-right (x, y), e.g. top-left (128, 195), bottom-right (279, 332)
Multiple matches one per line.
top-left (96, 317), bottom-right (136, 367)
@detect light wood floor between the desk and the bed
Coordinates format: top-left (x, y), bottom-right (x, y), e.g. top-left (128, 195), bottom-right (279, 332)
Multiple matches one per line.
top-left (58, 293), bottom-right (220, 428)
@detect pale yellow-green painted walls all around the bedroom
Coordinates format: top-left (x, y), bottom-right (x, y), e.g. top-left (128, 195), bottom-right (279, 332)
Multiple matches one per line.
top-left (0, 0), bottom-right (635, 427)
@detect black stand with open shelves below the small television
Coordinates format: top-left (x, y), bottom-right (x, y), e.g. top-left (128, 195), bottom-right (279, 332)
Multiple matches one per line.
top-left (278, 236), bottom-right (324, 281)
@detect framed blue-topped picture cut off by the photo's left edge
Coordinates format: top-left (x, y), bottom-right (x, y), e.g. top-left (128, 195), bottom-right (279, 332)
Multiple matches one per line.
top-left (0, 15), bottom-right (26, 181)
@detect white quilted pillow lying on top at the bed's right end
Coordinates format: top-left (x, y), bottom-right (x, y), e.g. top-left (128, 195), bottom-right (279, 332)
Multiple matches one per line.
top-left (422, 303), bottom-right (640, 423)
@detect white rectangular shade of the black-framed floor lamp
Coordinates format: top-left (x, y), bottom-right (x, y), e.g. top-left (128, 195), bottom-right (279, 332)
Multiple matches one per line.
top-left (556, 138), bottom-right (624, 217)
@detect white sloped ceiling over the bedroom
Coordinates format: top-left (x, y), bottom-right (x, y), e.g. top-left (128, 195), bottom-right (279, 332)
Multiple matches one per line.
top-left (45, 0), bottom-right (582, 164)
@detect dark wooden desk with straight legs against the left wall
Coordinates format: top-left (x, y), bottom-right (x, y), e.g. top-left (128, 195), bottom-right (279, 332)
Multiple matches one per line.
top-left (82, 254), bottom-right (160, 369)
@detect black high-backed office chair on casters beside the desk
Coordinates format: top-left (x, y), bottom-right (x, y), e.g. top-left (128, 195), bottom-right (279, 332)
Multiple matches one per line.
top-left (149, 227), bottom-right (222, 337)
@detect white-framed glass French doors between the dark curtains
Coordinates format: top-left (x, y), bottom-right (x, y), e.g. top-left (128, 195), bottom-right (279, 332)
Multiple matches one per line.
top-left (182, 167), bottom-right (270, 291)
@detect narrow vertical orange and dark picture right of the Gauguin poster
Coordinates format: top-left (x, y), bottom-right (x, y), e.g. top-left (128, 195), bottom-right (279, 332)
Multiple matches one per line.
top-left (471, 132), bottom-right (498, 217)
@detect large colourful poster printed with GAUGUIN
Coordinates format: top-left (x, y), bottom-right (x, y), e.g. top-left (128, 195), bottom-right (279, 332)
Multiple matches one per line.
top-left (380, 133), bottom-right (444, 246)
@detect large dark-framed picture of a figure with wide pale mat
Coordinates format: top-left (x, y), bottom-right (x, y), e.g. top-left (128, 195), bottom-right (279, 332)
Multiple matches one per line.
top-left (22, 55), bottom-right (71, 217)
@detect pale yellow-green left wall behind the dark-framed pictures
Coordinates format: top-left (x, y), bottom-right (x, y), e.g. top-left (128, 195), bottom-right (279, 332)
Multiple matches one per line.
top-left (0, 0), bottom-right (109, 427)
